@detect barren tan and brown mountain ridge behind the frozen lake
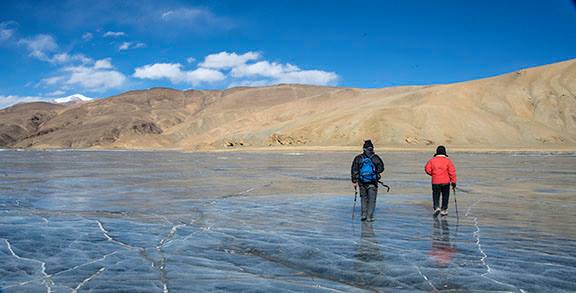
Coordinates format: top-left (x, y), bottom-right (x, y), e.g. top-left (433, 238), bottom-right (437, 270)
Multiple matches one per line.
top-left (0, 60), bottom-right (576, 150)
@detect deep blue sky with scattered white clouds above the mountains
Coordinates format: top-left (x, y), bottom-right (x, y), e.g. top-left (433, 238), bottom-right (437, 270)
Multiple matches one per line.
top-left (0, 0), bottom-right (576, 107)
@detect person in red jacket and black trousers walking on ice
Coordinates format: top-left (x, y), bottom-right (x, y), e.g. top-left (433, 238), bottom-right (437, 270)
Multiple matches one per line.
top-left (424, 145), bottom-right (456, 216)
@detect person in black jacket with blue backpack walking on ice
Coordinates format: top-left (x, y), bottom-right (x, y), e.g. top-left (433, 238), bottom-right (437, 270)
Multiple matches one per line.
top-left (351, 140), bottom-right (384, 222)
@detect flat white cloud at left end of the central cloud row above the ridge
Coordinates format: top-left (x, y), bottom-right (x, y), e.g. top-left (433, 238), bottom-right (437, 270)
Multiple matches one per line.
top-left (133, 63), bottom-right (226, 85)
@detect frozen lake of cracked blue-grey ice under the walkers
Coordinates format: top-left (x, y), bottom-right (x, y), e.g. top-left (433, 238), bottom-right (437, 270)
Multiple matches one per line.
top-left (0, 150), bottom-right (576, 292)
